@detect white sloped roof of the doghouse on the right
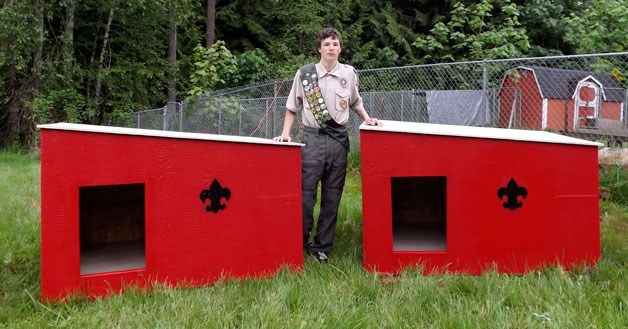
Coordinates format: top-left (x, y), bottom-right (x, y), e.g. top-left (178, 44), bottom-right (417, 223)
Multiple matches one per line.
top-left (360, 120), bottom-right (603, 147)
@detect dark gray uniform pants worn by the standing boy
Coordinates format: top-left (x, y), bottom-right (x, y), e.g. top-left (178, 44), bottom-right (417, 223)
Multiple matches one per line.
top-left (301, 127), bottom-right (349, 252)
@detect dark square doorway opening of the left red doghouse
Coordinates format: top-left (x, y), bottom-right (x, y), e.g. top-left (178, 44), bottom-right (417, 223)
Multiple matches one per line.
top-left (79, 184), bottom-right (146, 275)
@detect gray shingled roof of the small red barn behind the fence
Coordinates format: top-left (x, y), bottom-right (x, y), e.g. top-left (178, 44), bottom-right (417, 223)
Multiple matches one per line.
top-left (519, 66), bottom-right (626, 102)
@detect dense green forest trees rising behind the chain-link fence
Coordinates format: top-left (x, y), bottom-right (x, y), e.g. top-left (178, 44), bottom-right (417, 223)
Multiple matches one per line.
top-left (0, 0), bottom-right (628, 147)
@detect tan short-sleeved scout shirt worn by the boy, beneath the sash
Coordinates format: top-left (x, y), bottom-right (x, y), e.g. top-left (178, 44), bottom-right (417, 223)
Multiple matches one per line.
top-left (286, 63), bottom-right (364, 128)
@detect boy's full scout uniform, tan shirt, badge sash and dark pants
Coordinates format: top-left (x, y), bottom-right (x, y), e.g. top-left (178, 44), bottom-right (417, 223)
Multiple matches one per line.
top-left (286, 63), bottom-right (364, 252)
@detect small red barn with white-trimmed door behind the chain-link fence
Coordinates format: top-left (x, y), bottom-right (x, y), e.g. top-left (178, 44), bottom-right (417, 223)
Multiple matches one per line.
top-left (498, 66), bottom-right (628, 140)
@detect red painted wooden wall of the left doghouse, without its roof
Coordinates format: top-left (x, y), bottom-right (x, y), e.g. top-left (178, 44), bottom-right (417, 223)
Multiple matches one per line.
top-left (41, 125), bottom-right (303, 301)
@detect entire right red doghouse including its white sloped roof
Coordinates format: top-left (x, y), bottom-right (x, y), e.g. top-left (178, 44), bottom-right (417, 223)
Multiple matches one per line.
top-left (360, 121), bottom-right (600, 274)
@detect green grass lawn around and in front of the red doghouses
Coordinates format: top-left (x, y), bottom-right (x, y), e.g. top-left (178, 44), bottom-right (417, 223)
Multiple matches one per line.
top-left (0, 151), bottom-right (628, 328)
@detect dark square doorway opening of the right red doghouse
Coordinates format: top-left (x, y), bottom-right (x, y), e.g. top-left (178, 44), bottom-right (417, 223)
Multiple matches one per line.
top-left (391, 176), bottom-right (447, 251)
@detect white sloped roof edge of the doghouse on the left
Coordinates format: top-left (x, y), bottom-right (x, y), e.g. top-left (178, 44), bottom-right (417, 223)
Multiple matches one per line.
top-left (37, 122), bottom-right (305, 147)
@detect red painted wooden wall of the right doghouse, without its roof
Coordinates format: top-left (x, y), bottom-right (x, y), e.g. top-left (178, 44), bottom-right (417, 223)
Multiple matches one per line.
top-left (360, 122), bottom-right (600, 274)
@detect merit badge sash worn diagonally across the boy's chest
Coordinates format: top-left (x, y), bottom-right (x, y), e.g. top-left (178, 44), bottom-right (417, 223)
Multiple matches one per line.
top-left (300, 64), bottom-right (349, 149)
